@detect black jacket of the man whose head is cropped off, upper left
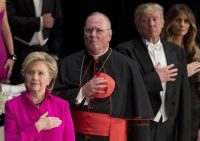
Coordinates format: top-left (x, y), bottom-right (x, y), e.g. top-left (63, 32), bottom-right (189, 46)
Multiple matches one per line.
top-left (7, 0), bottom-right (62, 55)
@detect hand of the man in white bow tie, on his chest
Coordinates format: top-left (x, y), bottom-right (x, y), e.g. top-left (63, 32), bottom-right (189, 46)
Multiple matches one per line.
top-left (155, 64), bottom-right (178, 82)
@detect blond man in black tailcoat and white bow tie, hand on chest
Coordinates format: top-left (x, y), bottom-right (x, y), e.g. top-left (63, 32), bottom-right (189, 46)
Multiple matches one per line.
top-left (116, 3), bottom-right (191, 141)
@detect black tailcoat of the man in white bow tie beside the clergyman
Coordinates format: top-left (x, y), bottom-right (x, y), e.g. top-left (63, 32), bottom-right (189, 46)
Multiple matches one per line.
top-left (115, 39), bottom-right (191, 141)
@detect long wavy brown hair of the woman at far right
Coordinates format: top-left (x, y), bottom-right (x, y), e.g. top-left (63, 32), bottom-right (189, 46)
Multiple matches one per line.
top-left (161, 4), bottom-right (200, 61)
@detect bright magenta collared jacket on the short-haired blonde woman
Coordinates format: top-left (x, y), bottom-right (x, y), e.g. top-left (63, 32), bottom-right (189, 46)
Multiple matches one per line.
top-left (4, 91), bottom-right (75, 141)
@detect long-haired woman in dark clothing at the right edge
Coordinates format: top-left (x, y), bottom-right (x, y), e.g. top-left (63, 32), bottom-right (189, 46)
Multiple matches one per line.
top-left (162, 4), bottom-right (200, 141)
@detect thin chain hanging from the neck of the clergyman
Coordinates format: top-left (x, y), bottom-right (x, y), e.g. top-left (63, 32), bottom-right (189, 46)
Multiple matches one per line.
top-left (80, 48), bottom-right (112, 87)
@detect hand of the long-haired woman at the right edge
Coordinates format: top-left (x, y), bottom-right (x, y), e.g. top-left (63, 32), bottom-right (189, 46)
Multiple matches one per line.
top-left (187, 61), bottom-right (200, 77)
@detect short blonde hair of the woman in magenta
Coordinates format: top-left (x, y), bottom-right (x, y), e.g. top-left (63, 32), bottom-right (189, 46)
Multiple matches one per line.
top-left (21, 52), bottom-right (58, 91)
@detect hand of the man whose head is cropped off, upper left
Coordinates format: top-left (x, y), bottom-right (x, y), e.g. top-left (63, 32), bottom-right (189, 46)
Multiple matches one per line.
top-left (42, 13), bottom-right (54, 28)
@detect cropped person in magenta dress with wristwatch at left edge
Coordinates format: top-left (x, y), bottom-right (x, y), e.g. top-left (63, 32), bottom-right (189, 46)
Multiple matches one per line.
top-left (0, 0), bottom-right (16, 82)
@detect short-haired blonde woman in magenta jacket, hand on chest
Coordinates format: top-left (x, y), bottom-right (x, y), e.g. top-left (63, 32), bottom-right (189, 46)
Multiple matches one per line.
top-left (4, 52), bottom-right (75, 141)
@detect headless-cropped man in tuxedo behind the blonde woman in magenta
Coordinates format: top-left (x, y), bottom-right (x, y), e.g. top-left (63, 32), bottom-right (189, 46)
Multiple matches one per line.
top-left (7, 0), bottom-right (62, 84)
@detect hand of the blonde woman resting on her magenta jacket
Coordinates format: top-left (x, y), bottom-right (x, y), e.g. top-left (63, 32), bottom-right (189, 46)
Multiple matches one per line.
top-left (35, 111), bottom-right (62, 132)
